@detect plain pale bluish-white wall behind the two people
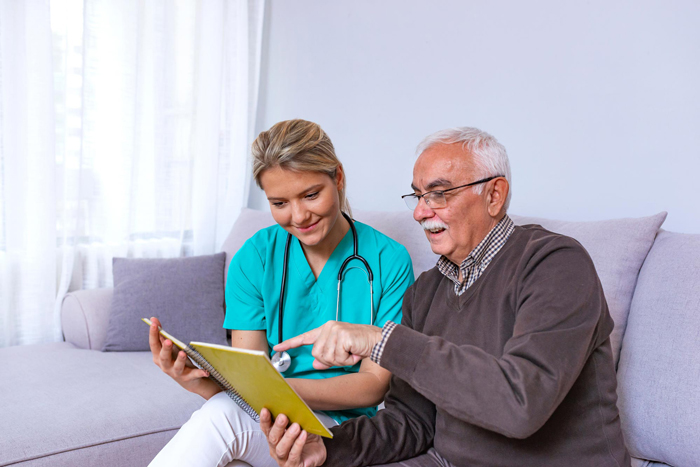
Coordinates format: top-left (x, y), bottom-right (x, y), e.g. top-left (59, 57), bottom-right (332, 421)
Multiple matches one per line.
top-left (249, 0), bottom-right (700, 233)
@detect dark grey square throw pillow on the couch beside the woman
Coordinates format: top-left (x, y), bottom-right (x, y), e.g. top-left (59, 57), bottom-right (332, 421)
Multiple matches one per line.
top-left (102, 253), bottom-right (226, 351)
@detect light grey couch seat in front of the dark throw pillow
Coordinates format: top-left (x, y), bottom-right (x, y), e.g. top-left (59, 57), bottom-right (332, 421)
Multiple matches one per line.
top-left (0, 342), bottom-right (204, 466)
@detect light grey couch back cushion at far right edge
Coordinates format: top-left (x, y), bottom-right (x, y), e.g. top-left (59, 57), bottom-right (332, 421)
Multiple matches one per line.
top-left (618, 232), bottom-right (700, 466)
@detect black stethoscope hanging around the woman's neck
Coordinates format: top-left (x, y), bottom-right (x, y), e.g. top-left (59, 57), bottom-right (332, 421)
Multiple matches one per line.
top-left (271, 212), bottom-right (374, 373)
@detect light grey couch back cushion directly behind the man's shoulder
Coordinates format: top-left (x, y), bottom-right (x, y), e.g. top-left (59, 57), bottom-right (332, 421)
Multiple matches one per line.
top-left (511, 212), bottom-right (666, 363)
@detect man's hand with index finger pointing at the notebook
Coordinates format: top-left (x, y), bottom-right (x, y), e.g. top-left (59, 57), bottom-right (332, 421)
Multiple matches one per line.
top-left (273, 321), bottom-right (382, 370)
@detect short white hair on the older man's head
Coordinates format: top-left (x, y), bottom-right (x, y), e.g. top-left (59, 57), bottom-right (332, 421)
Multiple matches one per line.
top-left (416, 126), bottom-right (513, 211)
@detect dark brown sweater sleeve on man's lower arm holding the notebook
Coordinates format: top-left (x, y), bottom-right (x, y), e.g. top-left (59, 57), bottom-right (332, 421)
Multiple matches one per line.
top-left (323, 286), bottom-right (435, 467)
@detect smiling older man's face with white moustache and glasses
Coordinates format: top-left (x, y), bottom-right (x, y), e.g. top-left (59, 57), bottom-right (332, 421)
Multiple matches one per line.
top-left (412, 143), bottom-right (495, 265)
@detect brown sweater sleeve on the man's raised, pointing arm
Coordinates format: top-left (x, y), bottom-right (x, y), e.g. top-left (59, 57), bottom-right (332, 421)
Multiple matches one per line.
top-left (382, 238), bottom-right (612, 439)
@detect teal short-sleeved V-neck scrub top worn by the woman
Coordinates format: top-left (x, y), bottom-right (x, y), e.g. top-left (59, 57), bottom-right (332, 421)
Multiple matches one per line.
top-left (224, 222), bottom-right (414, 423)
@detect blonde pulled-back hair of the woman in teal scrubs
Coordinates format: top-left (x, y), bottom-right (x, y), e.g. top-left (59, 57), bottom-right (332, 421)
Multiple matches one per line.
top-left (252, 119), bottom-right (351, 215)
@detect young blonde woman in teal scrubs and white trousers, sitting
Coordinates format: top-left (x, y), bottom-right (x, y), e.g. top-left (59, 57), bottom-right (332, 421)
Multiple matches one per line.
top-left (149, 120), bottom-right (413, 467)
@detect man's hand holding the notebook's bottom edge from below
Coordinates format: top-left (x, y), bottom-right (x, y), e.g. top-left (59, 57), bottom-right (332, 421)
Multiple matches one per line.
top-left (260, 409), bottom-right (326, 467)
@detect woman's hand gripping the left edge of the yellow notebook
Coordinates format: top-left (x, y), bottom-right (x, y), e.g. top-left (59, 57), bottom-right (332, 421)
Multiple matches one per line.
top-left (148, 318), bottom-right (221, 399)
